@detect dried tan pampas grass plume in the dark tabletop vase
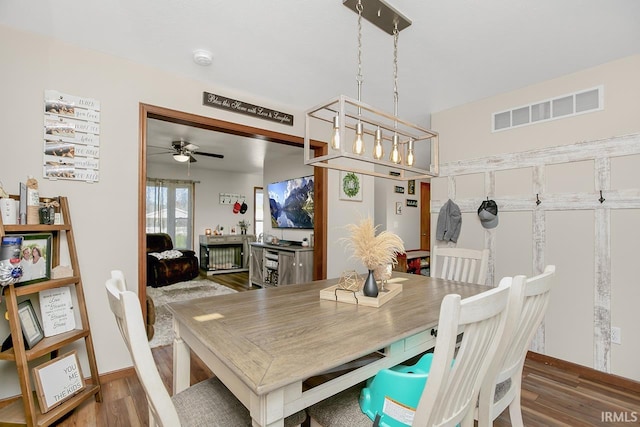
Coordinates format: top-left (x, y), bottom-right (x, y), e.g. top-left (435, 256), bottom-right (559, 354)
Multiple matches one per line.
top-left (340, 218), bottom-right (404, 270)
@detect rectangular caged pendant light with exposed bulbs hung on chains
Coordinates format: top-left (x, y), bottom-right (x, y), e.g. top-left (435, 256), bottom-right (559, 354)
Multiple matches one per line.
top-left (304, 0), bottom-right (438, 181)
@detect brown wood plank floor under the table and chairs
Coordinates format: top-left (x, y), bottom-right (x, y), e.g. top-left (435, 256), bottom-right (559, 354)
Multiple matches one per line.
top-left (41, 273), bottom-right (640, 427)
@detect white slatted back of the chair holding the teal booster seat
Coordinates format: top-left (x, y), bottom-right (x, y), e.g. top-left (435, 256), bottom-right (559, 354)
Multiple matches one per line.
top-left (412, 283), bottom-right (510, 427)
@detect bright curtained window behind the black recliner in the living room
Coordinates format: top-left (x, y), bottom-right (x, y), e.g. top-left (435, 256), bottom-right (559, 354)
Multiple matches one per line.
top-left (146, 178), bottom-right (194, 249)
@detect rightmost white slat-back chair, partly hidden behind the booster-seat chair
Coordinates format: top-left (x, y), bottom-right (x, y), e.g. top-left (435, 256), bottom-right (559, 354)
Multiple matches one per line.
top-left (477, 265), bottom-right (556, 427)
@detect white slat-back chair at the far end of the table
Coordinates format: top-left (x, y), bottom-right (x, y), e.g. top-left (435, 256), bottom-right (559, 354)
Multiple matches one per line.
top-left (429, 246), bottom-right (489, 285)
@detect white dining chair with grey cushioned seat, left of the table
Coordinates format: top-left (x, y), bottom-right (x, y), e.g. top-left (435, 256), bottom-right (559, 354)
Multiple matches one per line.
top-left (106, 270), bottom-right (306, 427)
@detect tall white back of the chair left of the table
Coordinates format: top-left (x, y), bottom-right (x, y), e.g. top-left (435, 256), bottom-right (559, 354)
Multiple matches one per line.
top-left (106, 271), bottom-right (180, 427)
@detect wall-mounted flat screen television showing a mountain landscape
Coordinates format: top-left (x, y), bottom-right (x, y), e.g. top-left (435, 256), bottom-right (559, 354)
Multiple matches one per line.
top-left (267, 175), bottom-right (314, 229)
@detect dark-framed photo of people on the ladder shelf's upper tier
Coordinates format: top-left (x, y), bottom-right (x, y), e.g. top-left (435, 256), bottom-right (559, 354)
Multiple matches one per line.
top-left (18, 233), bottom-right (52, 284)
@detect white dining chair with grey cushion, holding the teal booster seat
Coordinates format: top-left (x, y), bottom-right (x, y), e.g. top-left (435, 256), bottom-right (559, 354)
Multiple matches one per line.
top-left (307, 282), bottom-right (510, 427)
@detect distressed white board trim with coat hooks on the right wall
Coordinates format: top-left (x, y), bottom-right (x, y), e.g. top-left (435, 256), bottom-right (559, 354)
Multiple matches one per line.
top-left (431, 134), bottom-right (640, 372)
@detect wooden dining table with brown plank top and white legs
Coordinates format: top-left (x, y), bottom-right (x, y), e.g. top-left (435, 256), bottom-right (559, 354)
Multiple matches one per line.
top-left (167, 272), bottom-right (488, 427)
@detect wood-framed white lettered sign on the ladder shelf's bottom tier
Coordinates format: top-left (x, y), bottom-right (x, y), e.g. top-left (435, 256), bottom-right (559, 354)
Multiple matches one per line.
top-left (33, 350), bottom-right (85, 414)
